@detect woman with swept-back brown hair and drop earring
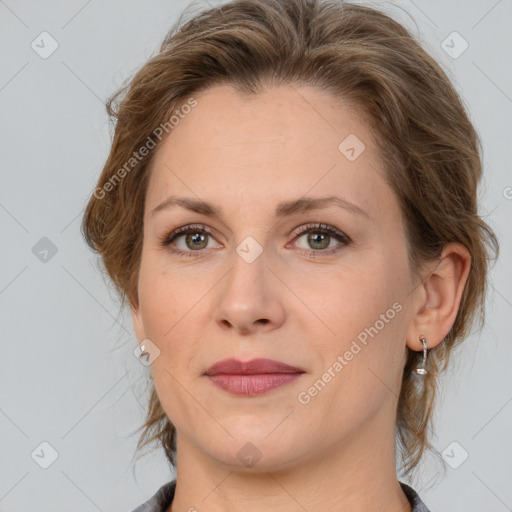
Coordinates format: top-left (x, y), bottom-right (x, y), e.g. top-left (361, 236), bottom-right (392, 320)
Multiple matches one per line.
top-left (83, 0), bottom-right (498, 512)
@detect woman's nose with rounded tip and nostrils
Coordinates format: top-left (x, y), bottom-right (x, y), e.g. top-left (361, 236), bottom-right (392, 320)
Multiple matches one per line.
top-left (215, 244), bottom-right (285, 335)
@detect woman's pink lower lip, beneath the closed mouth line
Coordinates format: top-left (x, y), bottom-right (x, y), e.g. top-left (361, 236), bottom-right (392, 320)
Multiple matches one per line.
top-left (209, 373), bottom-right (302, 396)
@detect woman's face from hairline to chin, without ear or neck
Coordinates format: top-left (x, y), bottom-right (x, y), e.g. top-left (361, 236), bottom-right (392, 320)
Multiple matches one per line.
top-left (133, 85), bottom-right (420, 469)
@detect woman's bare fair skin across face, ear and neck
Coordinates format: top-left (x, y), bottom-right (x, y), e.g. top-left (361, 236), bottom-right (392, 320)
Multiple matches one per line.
top-left (132, 85), bottom-right (470, 512)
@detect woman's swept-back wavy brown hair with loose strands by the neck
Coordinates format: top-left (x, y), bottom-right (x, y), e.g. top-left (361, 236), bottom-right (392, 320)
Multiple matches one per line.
top-left (82, 0), bottom-right (499, 475)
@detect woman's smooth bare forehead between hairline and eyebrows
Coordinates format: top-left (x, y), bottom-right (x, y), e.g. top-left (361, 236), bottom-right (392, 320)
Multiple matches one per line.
top-left (146, 85), bottom-right (394, 222)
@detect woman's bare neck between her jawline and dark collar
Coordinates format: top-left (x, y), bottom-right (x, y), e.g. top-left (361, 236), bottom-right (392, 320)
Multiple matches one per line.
top-left (168, 408), bottom-right (412, 512)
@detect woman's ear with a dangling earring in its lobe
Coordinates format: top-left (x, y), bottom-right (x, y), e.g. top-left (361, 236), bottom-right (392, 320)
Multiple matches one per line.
top-left (407, 242), bottom-right (471, 350)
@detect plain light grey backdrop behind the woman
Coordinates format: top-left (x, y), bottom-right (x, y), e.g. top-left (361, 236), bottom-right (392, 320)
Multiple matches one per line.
top-left (0, 0), bottom-right (512, 512)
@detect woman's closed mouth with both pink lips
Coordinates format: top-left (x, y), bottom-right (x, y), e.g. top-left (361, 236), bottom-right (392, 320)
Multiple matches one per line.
top-left (205, 359), bottom-right (305, 396)
